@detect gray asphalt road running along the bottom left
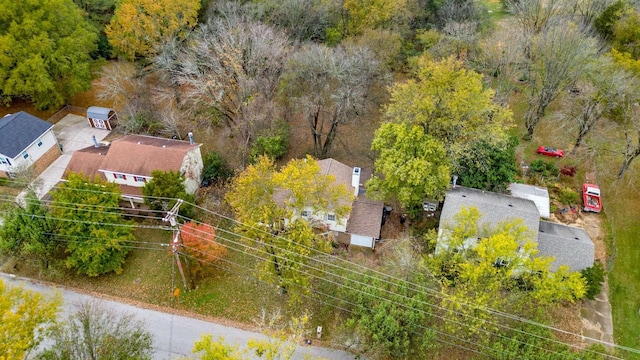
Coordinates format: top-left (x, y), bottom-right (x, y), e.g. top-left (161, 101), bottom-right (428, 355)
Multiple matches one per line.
top-left (0, 273), bottom-right (355, 360)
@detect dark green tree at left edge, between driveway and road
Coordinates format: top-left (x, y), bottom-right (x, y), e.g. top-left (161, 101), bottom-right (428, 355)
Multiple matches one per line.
top-left (0, 193), bottom-right (58, 269)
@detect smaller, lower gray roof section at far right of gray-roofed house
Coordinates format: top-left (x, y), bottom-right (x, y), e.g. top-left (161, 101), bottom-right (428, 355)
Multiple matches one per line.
top-left (538, 221), bottom-right (595, 271)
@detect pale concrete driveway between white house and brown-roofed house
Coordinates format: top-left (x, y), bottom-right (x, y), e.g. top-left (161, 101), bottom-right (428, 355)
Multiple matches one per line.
top-left (17, 114), bottom-right (110, 203)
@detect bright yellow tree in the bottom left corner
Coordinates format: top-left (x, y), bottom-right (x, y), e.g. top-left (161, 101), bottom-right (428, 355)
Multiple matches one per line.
top-left (0, 279), bottom-right (62, 360)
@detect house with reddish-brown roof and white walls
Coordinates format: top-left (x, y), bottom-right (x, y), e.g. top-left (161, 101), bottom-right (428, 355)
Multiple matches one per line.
top-left (63, 134), bottom-right (203, 207)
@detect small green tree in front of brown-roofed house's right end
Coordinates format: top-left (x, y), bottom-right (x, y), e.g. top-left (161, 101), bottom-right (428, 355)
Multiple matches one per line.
top-left (142, 170), bottom-right (194, 217)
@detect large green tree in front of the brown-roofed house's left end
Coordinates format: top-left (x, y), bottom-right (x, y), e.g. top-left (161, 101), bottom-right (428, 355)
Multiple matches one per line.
top-left (51, 174), bottom-right (135, 277)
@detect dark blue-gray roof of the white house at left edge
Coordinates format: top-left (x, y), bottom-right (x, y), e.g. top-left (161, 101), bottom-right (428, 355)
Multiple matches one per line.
top-left (0, 111), bottom-right (53, 158)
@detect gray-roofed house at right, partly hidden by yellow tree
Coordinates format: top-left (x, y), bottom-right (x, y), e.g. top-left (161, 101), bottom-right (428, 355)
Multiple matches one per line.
top-left (438, 186), bottom-right (595, 271)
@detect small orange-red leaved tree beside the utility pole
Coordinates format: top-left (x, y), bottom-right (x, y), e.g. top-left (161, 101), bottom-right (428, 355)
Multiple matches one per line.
top-left (181, 222), bottom-right (227, 275)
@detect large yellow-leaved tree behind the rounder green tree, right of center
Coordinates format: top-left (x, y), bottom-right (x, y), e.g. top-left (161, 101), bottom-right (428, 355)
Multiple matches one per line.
top-left (385, 58), bottom-right (512, 159)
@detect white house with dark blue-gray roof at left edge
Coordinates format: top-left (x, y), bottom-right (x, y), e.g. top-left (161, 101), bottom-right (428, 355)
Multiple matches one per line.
top-left (0, 111), bottom-right (60, 177)
